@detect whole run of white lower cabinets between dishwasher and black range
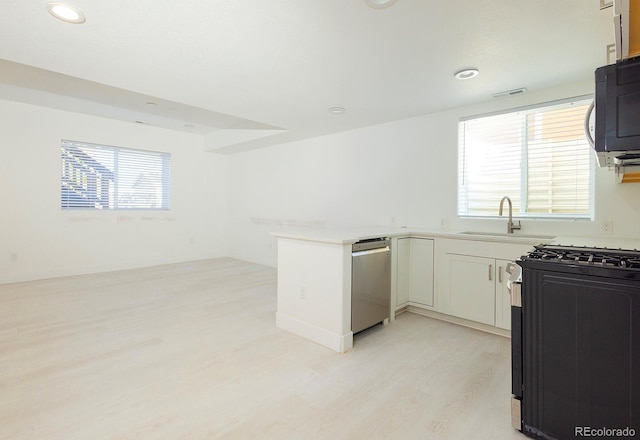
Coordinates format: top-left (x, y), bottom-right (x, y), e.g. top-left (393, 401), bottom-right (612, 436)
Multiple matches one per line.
top-left (395, 237), bottom-right (532, 334)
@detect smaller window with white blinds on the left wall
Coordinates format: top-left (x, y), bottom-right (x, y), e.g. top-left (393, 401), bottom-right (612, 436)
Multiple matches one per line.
top-left (61, 140), bottom-right (171, 209)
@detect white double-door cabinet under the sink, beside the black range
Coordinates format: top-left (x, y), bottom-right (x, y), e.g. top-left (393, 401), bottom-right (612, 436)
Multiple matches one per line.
top-left (445, 254), bottom-right (511, 330)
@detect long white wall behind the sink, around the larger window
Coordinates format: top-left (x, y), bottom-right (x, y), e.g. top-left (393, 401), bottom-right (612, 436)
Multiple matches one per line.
top-left (229, 83), bottom-right (640, 265)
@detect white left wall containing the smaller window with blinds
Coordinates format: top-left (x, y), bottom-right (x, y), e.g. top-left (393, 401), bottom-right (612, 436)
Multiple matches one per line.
top-left (0, 100), bottom-right (227, 283)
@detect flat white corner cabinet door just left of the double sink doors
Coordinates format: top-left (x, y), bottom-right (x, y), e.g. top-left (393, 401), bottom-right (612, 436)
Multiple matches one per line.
top-left (409, 238), bottom-right (433, 307)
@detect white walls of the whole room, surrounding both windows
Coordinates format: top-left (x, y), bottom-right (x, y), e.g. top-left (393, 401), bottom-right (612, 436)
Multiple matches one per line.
top-left (5, 77), bottom-right (640, 283)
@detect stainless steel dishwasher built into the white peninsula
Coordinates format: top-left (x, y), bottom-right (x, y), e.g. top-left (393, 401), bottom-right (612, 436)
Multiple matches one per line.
top-left (351, 238), bottom-right (391, 333)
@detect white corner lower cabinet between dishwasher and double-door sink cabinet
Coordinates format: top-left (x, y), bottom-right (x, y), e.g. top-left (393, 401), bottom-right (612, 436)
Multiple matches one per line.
top-left (396, 238), bottom-right (433, 307)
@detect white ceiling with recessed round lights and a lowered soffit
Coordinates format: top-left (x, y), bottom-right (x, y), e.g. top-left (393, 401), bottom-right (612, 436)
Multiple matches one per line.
top-left (0, 0), bottom-right (613, 153)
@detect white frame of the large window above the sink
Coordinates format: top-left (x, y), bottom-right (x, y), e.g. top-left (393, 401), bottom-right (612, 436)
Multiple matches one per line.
top-left (456, 95), bottom-right (596, 221)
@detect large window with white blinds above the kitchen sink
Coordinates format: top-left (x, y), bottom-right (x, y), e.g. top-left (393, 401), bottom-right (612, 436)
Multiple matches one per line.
top-left (458, 99), bottom-right (593, 219)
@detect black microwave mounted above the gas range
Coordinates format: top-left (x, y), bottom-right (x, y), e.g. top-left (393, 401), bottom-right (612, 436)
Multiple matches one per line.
top-left (594, 57), bottom-right (640, 166)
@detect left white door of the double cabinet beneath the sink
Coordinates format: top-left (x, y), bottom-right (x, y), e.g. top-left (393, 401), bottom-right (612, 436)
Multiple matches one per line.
top-left (447, 254), bottom-right (496, 325)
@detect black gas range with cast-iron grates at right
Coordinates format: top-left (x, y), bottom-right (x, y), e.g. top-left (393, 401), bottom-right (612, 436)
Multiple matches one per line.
top-left (510, 244), bottom-right (640, 440)
